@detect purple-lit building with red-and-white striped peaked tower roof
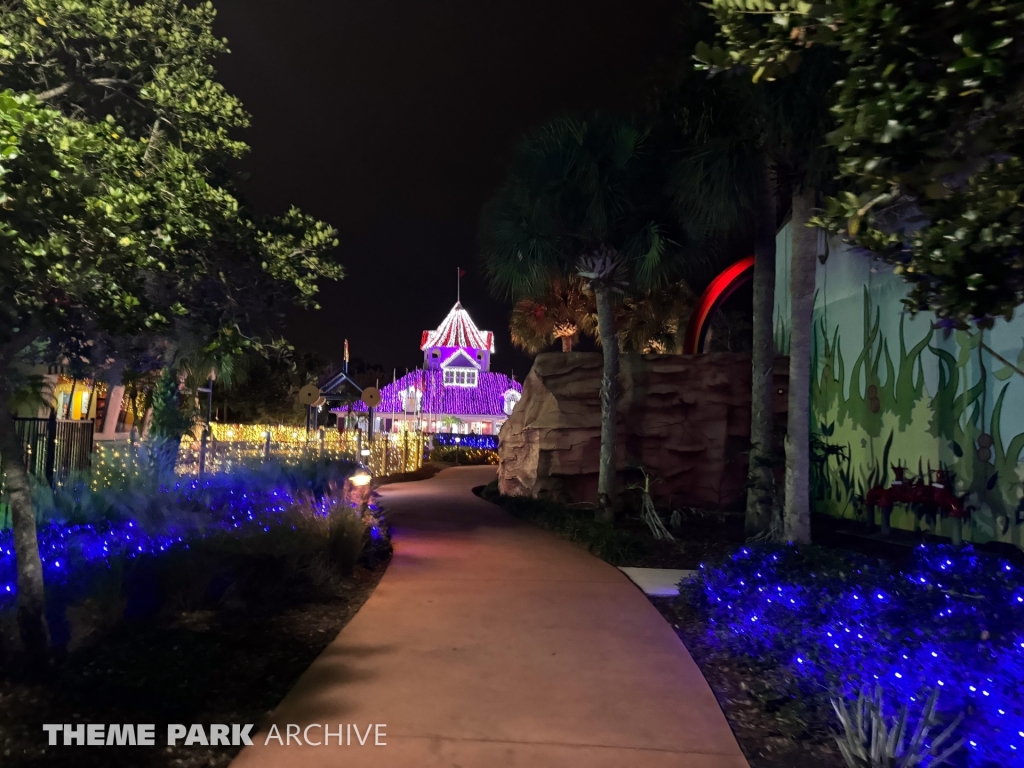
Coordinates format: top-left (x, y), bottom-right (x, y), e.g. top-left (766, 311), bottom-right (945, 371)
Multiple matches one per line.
top-left (337, 302), bottom-right (522, 434)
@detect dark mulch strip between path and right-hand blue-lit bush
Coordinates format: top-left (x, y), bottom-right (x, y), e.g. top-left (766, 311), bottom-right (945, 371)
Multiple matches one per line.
top-left (650, 597), bottom-right (846, 768)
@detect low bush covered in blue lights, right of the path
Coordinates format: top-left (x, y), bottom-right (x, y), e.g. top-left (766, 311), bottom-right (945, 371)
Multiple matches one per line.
top-left (686, 545), bottom-right (1024, 766)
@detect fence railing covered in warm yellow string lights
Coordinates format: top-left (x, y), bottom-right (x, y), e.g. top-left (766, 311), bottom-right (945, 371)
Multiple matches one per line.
top-left (177, 424), bottom-right (426, 476)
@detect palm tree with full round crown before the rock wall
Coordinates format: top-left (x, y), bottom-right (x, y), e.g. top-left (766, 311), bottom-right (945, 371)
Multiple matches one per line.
top-left (481, 117), bottom-right (682, 521)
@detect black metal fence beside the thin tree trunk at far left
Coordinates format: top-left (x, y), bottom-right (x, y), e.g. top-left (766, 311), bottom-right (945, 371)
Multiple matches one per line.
top-left (7, 417), bottom-right (93, 485)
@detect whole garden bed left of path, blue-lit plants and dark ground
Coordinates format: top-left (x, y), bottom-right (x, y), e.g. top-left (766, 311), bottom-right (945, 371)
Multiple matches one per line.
top-left (0, 462), bottom-right (391, 768)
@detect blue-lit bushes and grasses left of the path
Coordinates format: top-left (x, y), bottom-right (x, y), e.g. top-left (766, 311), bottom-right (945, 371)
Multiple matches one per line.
top-left (0, 456), bottom-right (390, 645)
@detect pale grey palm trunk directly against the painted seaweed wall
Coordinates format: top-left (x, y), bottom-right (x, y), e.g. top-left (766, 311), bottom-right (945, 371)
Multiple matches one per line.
top-left (782, 188), bottom-right (818, 544)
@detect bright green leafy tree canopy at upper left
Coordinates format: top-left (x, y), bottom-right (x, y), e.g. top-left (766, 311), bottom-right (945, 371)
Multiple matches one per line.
top-left (0, 0), bottom-right (342, 372)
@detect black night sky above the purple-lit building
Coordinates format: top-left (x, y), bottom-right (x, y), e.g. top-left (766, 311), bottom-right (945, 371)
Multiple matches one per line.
top-left (215, 0), bottom-right (679, 380)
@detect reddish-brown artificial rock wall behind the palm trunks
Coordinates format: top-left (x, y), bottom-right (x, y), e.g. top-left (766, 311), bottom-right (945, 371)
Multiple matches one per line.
top-left (498, 352), bottom-right (787, 509)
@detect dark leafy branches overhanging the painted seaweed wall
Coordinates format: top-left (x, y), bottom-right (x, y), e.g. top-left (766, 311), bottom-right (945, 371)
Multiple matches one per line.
top-left (697, 0), bottom-right (1024, 326)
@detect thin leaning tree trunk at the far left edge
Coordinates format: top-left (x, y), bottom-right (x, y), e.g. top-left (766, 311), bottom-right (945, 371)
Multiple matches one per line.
top-left (0, 397), bottom-right (50, 667)
